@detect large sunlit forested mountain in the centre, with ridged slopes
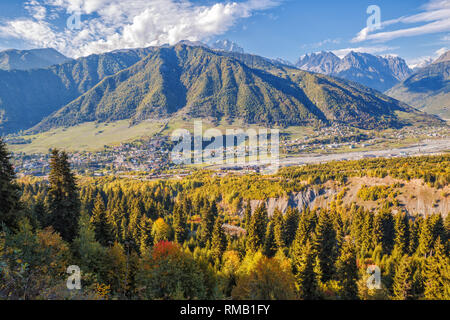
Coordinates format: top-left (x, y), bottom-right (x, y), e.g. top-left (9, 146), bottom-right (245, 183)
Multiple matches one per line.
top-left (32, 44), bottom-right (439, 132)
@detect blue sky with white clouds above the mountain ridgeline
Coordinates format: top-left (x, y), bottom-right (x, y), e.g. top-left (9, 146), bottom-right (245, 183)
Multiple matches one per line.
top-left (0, 0), bottom-right (450, 66)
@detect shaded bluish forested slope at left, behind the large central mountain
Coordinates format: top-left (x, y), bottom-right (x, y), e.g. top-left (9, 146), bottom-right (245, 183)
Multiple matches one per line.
top-left (0, 48), bottom-right (156, 135)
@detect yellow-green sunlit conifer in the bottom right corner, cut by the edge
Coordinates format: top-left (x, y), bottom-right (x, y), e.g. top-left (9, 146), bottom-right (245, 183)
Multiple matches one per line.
top-left (425, 238), bottom-right (450, 300)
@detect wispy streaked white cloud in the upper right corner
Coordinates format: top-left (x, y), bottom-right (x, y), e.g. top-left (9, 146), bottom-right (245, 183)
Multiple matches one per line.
top-left (352, 0), bottom-right (450, 42)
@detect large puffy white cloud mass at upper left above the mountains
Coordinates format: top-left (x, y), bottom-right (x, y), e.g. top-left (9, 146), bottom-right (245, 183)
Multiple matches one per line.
top-left (0, 0), bottom-right (280, 57)
